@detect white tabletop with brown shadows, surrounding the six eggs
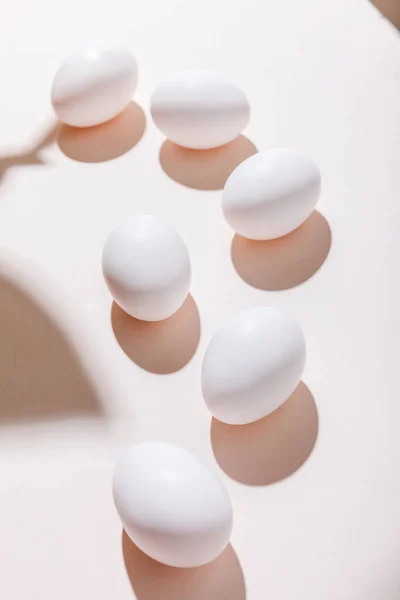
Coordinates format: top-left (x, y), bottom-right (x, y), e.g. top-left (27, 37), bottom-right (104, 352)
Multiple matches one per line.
top-left (0, 0), bottom-right (400, 600)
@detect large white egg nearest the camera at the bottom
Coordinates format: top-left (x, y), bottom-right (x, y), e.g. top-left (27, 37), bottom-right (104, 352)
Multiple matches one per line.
top-left (113, 442), bottom-right (232, 567)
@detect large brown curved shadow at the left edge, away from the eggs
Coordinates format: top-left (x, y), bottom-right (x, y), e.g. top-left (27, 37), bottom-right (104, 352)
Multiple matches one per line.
top-left (0, 276), bottom-right (102, 422)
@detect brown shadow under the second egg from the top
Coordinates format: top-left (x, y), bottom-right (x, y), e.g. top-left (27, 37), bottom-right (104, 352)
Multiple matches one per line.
top-left (160, 135), bottom-right (257, 190)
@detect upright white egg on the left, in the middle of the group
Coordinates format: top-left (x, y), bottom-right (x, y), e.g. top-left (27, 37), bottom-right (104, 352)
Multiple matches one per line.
top-left (102, 215), bottom-right (191, 321)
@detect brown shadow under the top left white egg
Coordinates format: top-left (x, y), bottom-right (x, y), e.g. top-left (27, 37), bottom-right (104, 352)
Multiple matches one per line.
top-left (57, 102), bottom-right (146, 163)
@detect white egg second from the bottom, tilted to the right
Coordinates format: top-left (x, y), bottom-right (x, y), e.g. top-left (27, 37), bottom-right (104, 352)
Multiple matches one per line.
top-left (202, 307), bottom-right (306, 425)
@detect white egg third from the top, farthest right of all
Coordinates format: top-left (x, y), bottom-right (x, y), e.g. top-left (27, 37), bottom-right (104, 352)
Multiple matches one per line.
top-left (222, 148), bottom-right (321, 240)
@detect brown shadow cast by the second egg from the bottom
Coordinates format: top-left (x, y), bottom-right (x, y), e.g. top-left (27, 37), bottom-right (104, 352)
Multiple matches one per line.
top-left (211, 383), bottom-right (318, 485)
